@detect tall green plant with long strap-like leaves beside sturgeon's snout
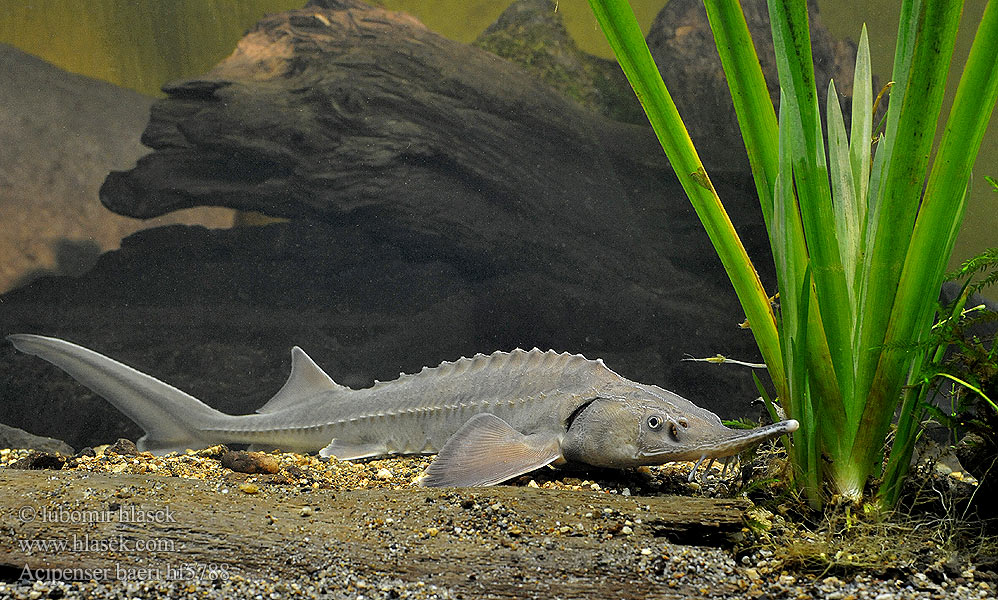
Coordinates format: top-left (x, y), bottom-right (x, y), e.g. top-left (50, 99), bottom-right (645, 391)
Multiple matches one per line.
top-left (590, 0), bottom-right (998, 507)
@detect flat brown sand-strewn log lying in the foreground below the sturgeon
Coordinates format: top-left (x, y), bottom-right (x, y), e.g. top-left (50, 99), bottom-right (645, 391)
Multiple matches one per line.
top-left (0, 470), bottom-right (747, 598)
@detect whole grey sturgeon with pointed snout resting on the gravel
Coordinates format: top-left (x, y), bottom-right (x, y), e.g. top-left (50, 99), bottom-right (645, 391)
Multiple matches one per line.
top-left (7, 334), bottom-right (798, 487)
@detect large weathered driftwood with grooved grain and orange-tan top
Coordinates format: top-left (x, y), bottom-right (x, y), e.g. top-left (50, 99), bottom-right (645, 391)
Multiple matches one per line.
top-left (101, 0), bottom-right (665, 279)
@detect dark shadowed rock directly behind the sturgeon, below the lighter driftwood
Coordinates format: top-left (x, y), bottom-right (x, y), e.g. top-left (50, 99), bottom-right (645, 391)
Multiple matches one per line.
top-left (0, 206), bottom-right (764, 446)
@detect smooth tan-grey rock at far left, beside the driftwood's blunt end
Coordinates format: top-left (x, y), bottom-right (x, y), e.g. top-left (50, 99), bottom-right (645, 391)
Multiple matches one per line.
top-left (0, 44), bottom-right (232, 291)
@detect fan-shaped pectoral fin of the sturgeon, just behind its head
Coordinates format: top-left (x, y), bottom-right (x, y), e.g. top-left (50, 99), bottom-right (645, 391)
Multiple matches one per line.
top-left (422, 413), bottom-right (562, 487)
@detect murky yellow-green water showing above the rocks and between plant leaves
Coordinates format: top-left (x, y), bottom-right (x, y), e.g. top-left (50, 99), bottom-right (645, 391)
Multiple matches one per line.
top-left (0, 0), bottom-right (998, 297)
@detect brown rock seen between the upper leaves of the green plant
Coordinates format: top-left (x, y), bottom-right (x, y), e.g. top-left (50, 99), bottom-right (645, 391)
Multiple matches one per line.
top-left (648, 0), bottom-right (859, 172)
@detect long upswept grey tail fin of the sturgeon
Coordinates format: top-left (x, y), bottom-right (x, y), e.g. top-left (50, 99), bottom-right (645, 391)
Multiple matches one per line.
top-left (7, 334), bottom-right (228, 453)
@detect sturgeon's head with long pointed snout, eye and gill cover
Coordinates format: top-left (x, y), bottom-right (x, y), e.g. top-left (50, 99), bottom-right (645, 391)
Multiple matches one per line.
top-left (562, 386), bottom-right (798, 468)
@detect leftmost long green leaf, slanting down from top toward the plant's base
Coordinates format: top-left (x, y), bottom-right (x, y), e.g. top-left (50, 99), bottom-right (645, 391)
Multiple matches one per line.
top-left (589, 0), bottom-right (784, 389)
